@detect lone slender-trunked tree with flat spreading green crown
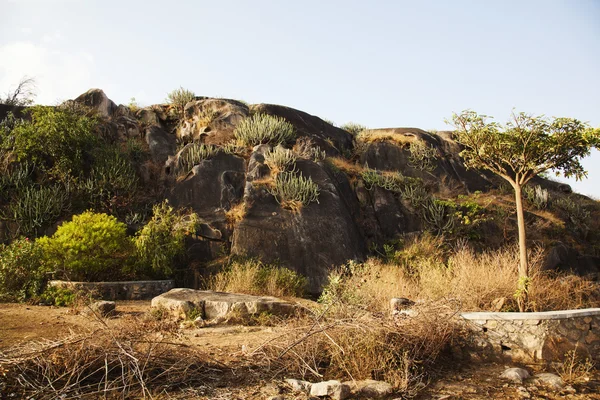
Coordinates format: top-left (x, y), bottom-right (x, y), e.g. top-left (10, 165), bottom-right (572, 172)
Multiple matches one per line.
top-left (450, 110), bottom-right (600, 311)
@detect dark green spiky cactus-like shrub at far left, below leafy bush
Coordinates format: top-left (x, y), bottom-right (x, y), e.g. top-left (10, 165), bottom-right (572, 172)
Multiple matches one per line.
top-left (4, 184), bottom-right (69, 236)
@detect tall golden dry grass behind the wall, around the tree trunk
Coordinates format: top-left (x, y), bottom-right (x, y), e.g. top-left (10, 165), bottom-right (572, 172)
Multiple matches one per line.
top-left (323, 236), bottom-right (600, 311)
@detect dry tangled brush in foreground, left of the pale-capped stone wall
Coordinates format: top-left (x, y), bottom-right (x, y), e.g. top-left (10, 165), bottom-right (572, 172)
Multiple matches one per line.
top-left (254, 304), bottom-right (456, 396)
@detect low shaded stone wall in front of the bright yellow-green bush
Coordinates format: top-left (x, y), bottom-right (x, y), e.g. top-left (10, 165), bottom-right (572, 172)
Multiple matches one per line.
top-left (48, 280), bottom-right (175, 300)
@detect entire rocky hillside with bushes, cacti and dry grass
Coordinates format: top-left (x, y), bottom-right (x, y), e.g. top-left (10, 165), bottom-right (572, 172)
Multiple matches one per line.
top-left (0, 89), bottom-right (600, 311)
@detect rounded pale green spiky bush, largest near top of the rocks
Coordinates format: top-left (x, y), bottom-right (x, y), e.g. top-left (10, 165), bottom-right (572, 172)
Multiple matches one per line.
top-left (234, 114), bottom-right (296, 146)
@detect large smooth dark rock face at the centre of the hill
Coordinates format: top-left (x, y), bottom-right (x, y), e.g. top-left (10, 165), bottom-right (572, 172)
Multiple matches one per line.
top-left (231, 155), bottom-right (366, 292)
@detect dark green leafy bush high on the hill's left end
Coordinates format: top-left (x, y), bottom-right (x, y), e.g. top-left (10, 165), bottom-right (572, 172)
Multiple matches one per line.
top-left (0, 106), bottom-right (98, 180)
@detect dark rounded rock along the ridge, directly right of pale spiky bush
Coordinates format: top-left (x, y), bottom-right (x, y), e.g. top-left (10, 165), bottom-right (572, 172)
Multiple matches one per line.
top-left (250, 104), bottom-right (354, 156)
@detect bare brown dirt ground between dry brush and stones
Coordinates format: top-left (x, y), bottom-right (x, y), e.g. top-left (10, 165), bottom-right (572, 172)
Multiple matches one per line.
top-left (0, 301), bottom-right (600, 400)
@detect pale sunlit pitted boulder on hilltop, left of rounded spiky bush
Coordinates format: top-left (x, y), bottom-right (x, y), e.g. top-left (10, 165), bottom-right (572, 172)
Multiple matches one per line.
top-left (177, 98), bottom-right (248, 144)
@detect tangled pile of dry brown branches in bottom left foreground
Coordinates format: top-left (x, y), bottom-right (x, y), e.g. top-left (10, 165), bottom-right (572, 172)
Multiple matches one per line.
top-left (0, 320), bottom-right (220, 399)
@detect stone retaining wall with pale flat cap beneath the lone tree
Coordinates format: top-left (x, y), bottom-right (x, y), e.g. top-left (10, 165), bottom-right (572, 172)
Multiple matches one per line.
top-left (461, 308), bottom-right (600, 362)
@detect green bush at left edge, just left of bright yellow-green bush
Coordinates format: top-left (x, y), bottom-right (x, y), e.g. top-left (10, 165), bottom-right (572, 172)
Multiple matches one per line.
top-left (0, 238), bottom-right (44, 301)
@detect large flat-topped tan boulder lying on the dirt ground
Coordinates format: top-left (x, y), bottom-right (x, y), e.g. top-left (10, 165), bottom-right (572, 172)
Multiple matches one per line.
top-left (152, 288), bottom-right (296, 319)
